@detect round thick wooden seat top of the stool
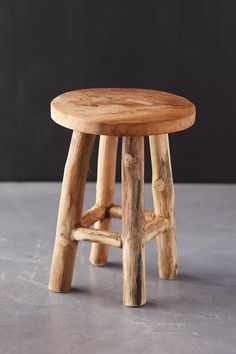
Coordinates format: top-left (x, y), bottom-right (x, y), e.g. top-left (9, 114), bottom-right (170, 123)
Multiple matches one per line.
top-left (51, 88), bottom-right (195, 136)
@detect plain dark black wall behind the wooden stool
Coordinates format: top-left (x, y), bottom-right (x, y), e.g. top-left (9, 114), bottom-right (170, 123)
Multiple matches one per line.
top-left (0, 0), bottom-right (236, 182)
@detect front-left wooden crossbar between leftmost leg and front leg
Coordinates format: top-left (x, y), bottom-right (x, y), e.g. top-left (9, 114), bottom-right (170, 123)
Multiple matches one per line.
top-left (71, 227), bottom-right (122, 248)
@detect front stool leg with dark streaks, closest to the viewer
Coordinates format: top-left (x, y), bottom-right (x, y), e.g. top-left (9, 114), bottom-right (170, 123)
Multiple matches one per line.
top-left (122, 137), bottom-right (146, 306)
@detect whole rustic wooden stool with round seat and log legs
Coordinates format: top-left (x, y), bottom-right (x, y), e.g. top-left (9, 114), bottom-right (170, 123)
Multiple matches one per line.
top-left (49, 89), bottom-right (195, 306)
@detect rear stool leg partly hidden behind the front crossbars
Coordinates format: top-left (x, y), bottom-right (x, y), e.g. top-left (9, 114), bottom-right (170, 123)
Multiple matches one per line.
top-left (90, 136), bottom-right (118, 265)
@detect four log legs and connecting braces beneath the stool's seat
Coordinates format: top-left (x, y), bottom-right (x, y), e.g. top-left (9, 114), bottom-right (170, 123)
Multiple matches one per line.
top-left (49, 131), bottom-right (177, 306)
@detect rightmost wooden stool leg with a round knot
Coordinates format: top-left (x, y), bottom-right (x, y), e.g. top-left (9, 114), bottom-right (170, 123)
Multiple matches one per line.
top-left (149, 134), bottom-right (178, 279)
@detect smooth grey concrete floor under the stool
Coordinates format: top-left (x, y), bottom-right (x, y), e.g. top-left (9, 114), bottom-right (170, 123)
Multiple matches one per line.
top-left (0, 183), bottom-right (236, 354)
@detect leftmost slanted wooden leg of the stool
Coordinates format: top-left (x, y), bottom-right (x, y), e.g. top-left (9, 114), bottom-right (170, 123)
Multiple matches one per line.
top-left (48, 131), bottom-right (94, 292)
